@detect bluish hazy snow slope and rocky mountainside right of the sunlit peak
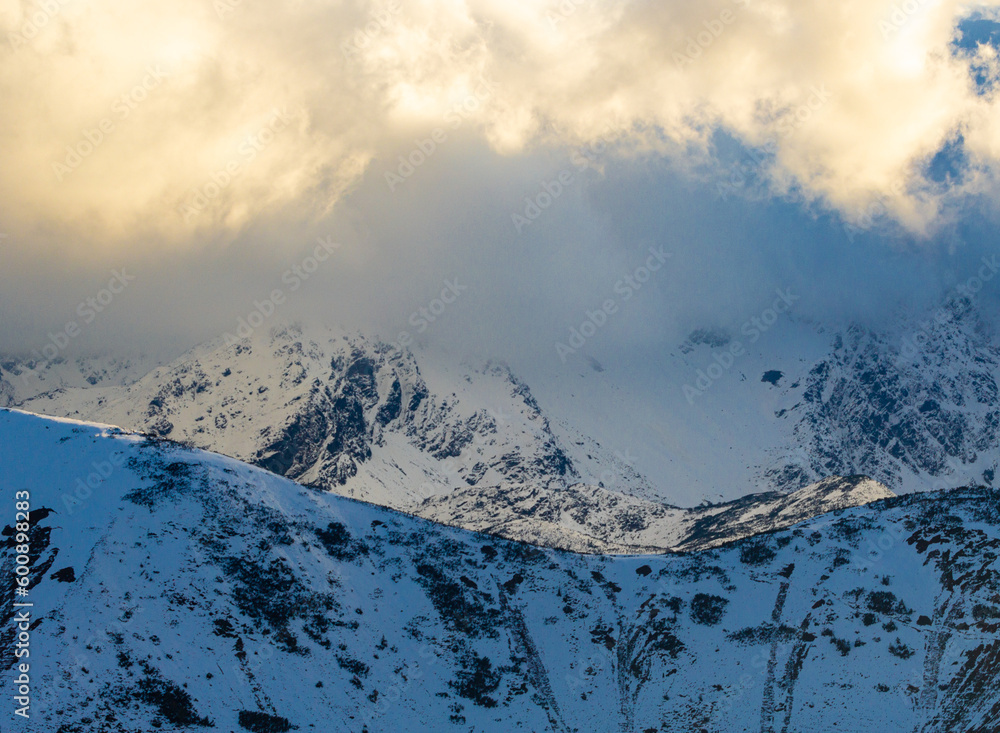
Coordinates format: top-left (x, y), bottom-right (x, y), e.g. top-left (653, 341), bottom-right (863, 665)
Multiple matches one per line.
top-left (522, 299), bottom-right (1000, 498)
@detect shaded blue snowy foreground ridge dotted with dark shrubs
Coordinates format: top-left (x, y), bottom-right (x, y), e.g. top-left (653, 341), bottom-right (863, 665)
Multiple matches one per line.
top-left (0, 411), bottom-right (1000, 733)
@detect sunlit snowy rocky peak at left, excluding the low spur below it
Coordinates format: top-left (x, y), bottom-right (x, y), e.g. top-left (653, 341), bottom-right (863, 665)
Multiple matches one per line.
top-left (15, 327), bottom-right (624, 507)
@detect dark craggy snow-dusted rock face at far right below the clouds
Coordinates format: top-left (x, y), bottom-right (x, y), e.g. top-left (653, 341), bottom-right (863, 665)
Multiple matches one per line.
top-left (774, 303), bottom-right (1000, 488)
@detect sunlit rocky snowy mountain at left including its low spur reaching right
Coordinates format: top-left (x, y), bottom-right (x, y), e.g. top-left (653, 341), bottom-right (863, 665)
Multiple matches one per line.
top-left (0, 326), bottom-right (891, 552)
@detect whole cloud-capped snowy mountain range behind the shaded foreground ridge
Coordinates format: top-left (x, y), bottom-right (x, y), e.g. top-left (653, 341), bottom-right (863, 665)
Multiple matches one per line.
top-left (7, 299), bottom-right (1000, 508)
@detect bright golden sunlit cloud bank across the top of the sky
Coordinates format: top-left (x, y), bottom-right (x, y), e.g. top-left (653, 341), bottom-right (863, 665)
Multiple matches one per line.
top-left (0, 0), bottom-right (1000, 252)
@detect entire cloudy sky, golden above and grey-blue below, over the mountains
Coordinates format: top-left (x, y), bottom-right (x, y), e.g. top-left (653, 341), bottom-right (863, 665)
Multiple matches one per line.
top-left (0, 0), bottom-right (1000, 360)
